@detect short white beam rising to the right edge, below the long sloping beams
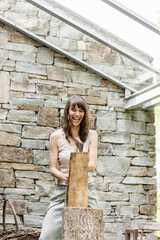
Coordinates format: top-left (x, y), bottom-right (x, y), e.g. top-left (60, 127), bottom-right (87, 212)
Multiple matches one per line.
top-left (125, 83), bottom-right (160, 109)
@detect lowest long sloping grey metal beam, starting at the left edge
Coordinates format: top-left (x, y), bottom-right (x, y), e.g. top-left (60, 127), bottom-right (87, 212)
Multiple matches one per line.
top-left (0, 17), bottom-right (136, 92)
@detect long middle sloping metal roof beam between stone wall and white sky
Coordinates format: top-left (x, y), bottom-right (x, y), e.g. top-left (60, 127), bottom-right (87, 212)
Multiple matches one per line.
top-left (26, 0), bottom-right (160, 75)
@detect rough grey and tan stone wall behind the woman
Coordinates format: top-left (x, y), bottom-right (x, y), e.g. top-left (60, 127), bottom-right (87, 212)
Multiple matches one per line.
top-left (0, 0), bottom-right (156, 240)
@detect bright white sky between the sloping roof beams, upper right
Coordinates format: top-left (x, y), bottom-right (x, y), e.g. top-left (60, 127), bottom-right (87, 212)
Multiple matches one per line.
top-left (57, 0), bottom-right (160, 65)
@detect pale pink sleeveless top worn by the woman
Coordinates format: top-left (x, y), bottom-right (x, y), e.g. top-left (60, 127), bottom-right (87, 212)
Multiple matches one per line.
top-left (57, 129), bottom-right (92, 185)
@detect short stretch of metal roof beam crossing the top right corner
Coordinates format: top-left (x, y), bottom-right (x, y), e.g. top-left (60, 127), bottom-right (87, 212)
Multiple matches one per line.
top-left (101, 0), bottom-right (160, 35)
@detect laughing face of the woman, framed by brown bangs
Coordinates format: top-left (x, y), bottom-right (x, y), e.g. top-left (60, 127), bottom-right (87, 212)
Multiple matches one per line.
top-left (69, 105), bottom-right (84, 127)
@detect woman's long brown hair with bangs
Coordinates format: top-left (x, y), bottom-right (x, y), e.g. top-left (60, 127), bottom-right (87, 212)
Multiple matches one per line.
top-left (61, 95), bottom-right (89, 142)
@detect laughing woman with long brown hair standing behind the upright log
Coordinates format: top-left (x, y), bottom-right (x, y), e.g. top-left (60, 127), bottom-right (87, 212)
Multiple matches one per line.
top-left (40, 96), bottom-right (97, 240)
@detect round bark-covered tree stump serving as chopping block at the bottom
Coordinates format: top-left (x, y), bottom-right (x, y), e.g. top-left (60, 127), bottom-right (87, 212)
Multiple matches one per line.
top-left (62, 207), bottom-right (104, 240)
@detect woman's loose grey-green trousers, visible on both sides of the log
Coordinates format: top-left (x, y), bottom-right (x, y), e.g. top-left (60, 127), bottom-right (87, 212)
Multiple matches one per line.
top-left (39, 184), bottom-right (98, 240)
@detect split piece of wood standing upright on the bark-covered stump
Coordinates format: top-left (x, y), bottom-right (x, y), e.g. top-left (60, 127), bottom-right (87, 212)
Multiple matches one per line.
top-left (66, 152), bottom-right (88, 207)
